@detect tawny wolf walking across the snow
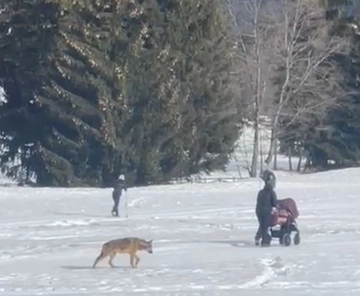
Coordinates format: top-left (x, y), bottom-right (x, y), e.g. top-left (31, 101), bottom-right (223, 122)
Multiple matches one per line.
top-left (93, 237), bottom-right (153, 268)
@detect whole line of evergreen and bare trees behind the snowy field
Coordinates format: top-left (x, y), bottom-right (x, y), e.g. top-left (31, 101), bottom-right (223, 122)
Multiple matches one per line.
top-left (0, 0), bottom-right (360, 186)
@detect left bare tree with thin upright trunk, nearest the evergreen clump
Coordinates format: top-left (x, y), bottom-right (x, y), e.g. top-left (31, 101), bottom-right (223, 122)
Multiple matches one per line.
top-left (226, 0), bottom-right (271, 177)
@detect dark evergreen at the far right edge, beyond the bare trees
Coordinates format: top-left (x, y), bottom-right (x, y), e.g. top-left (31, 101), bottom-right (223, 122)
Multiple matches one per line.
top-left (309, 0), bottom-right (360, 167)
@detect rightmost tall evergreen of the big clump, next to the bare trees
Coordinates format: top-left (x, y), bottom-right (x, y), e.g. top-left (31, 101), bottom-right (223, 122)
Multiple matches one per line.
top-left (169, 0), bottom-right (241, 173)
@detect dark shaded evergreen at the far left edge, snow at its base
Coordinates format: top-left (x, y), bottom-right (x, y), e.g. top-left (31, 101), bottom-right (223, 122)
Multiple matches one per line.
top-left (0, 0), bottom-right (57, 184)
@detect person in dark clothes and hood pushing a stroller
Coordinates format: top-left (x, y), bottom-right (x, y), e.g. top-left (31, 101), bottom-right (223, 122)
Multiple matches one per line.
top-left (255, 170), bottom-right (277, 247)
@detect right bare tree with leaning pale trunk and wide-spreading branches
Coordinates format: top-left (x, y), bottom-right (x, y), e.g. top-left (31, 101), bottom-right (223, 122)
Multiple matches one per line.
top-left (265, 0), bottom-right (346, 165)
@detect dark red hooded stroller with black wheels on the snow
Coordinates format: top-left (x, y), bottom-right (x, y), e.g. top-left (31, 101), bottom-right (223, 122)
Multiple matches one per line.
top-left (270, 198), bottom-right (300, 246)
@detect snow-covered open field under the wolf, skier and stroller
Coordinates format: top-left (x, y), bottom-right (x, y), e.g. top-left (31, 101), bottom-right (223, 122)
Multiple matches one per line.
top-left (0, 169), bottom-right (360, 296)
